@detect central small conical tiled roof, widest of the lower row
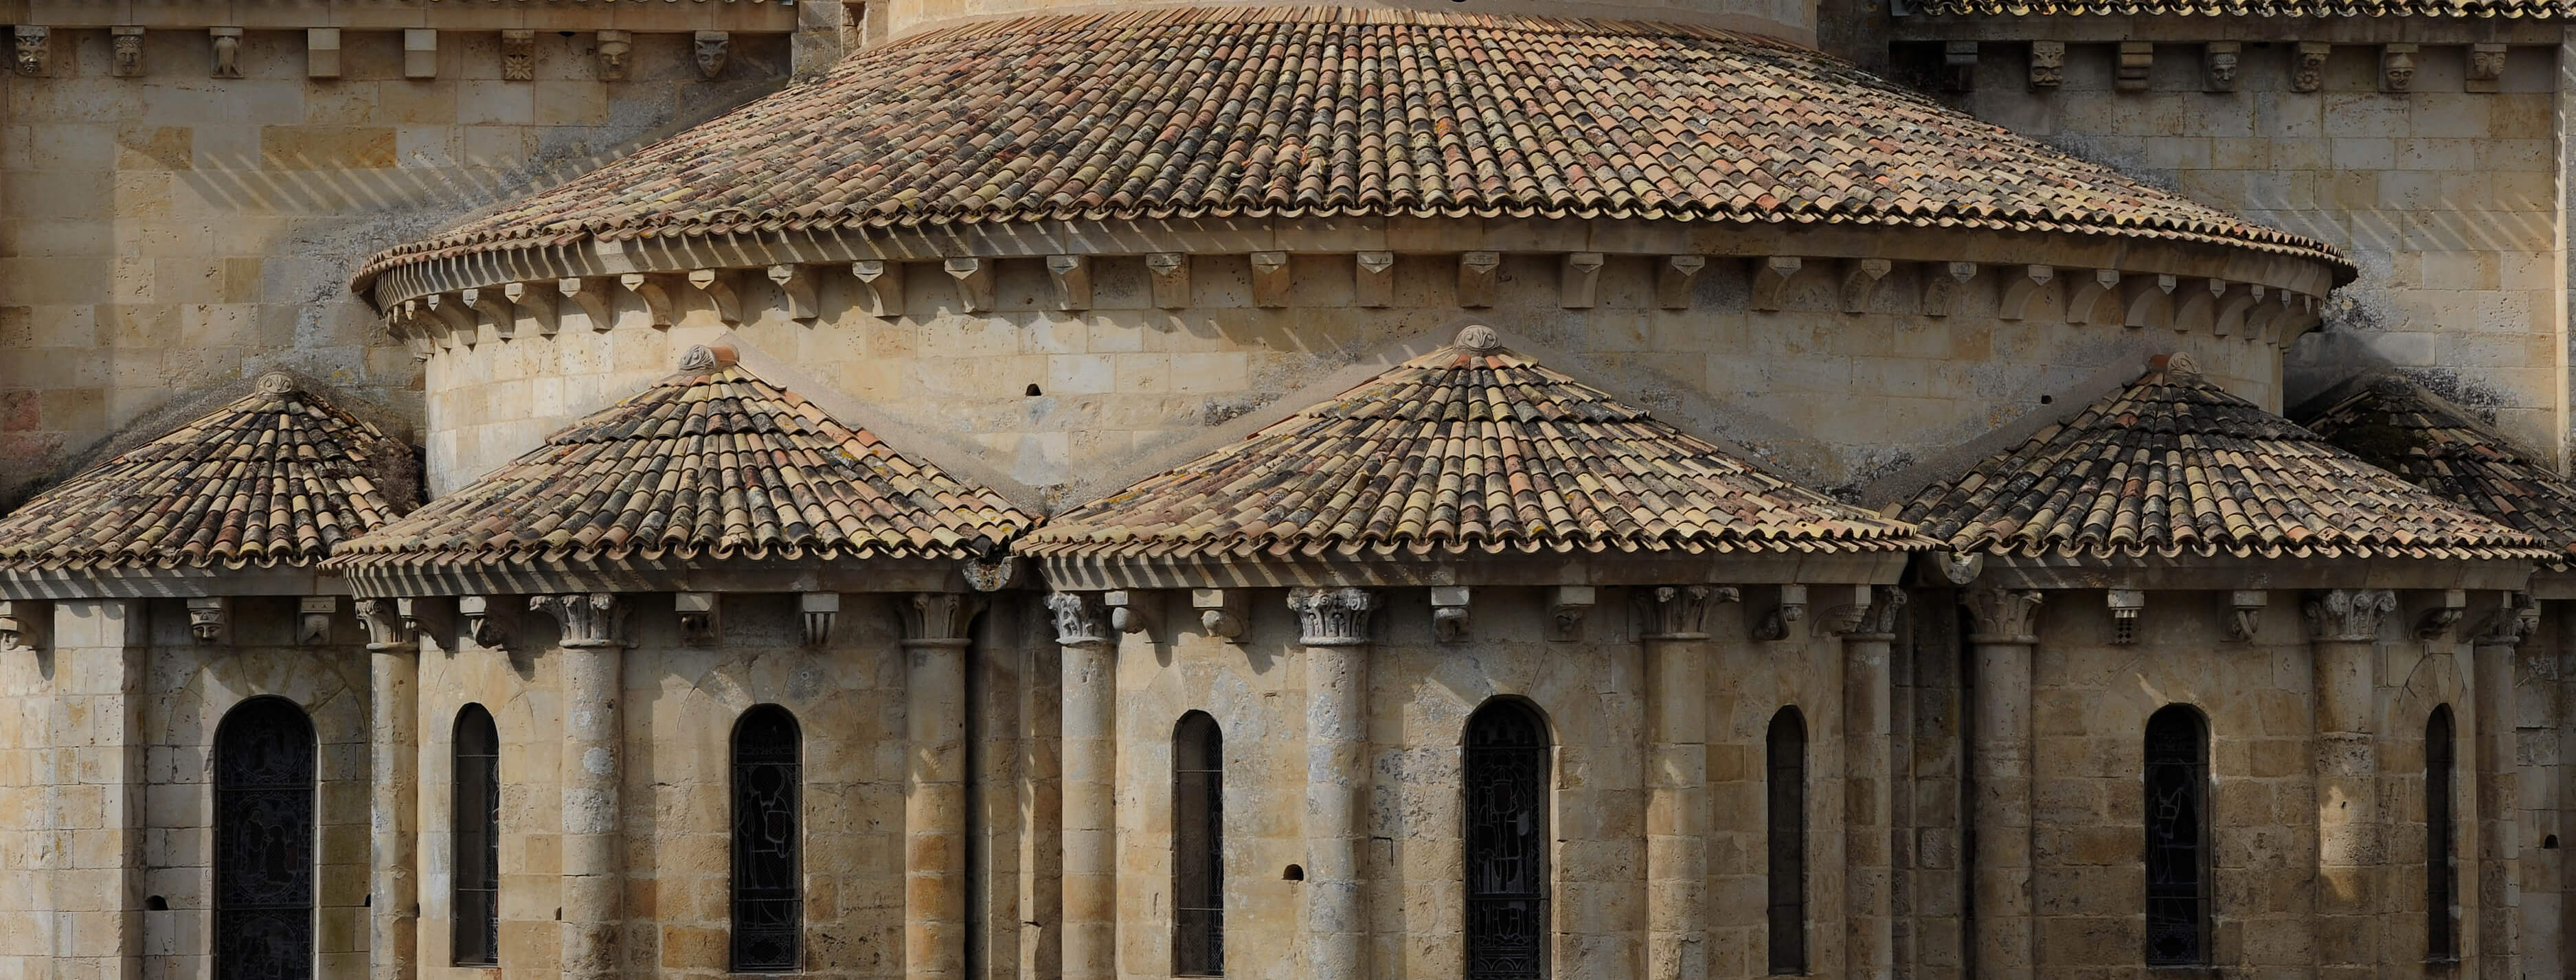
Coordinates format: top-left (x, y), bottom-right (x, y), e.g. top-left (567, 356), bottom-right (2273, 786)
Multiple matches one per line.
top-left (1017, 327), bottom-right (1919, 558)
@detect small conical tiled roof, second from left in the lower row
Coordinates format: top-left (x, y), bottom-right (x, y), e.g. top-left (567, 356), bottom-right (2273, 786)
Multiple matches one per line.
top-left (337, 347), bottom-right (1033, 566)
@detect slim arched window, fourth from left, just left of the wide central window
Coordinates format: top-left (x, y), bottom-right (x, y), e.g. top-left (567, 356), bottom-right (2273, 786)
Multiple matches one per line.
top-left (1172, 710), bottom-right (1226, 977)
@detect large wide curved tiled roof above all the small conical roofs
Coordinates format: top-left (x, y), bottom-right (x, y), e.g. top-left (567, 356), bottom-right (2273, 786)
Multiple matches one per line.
top-left (358, 8), bottom-right (2342, 286)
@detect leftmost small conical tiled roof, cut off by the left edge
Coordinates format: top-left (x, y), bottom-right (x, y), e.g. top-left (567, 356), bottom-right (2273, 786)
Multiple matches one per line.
top-left (0, 373), bottom-right (415, 571)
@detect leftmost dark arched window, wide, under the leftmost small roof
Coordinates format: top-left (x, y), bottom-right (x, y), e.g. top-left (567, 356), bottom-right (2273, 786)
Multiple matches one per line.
top-left (214, 697), bottom-right (315, 980)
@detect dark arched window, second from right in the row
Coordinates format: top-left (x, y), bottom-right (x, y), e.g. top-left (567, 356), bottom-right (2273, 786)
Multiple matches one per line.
top-left (2146, 705), bottom-right (2211, 967)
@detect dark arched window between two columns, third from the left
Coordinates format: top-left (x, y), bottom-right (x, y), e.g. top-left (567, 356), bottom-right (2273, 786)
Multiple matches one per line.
top-left (734, 705), bottom-right (804, 972)
